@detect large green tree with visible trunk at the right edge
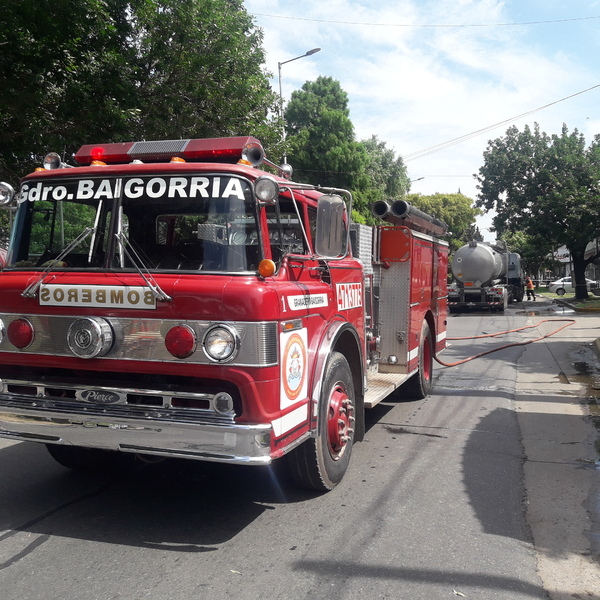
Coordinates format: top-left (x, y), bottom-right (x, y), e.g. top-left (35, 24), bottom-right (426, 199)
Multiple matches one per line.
top-left (477, 124), bottom-right (600, 300)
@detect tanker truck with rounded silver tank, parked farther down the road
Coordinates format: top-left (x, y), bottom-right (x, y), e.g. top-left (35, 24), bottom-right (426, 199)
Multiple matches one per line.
top-left (448, 241), bottom-right (525, 311)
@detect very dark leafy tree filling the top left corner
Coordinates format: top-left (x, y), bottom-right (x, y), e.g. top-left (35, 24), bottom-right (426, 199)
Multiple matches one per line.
top-left (0, 0), bottom-right (135, 183)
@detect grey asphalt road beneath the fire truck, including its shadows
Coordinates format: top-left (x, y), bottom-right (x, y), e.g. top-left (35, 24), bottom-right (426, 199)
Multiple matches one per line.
top-left (0, 304), bottom-right (587, 600)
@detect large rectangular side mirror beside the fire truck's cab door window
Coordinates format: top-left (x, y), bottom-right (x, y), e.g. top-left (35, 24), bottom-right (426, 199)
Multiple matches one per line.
top-left (315, 194), bottom-right (348, 258)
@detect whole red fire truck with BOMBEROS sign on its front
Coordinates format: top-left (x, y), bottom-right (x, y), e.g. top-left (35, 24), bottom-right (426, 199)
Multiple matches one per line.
top-left (0, 137), bottom-right (448, 490)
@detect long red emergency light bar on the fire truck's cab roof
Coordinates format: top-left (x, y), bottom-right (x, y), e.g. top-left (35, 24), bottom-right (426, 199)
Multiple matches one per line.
top-left (75, 136), bottom-right (264, 165)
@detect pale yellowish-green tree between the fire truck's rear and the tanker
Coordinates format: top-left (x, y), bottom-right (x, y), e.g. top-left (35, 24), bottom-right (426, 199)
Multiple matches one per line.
top-left (406, 193), bottom-right (481, 251)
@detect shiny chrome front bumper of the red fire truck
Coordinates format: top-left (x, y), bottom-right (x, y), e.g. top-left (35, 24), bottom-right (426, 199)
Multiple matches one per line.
top-left (0, 404), bottom-right (271, 465)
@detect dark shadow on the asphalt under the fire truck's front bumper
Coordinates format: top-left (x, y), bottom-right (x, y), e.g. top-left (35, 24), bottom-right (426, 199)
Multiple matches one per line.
top-left (0, 443), bottom-right (314, 552)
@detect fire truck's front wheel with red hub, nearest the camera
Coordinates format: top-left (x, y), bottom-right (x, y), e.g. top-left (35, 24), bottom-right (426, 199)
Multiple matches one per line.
top-left (286, 352), bottom-right (356, 492)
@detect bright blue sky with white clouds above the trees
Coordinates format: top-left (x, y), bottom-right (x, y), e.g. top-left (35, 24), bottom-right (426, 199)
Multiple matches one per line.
top-left (245, 0), bottom-right (600, 240)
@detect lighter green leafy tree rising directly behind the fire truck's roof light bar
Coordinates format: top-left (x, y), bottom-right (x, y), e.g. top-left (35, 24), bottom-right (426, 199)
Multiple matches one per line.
top-left (131, 0), bottom-right (280, 145)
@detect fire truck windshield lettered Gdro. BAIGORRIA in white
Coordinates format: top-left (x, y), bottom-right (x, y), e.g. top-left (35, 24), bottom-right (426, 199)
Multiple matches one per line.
top-left (6, 175), bottom-right (263, 272)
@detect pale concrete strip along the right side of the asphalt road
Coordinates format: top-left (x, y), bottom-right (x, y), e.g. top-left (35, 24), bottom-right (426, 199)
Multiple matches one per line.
top-left (515, 296), bottom-right (600, 600)
